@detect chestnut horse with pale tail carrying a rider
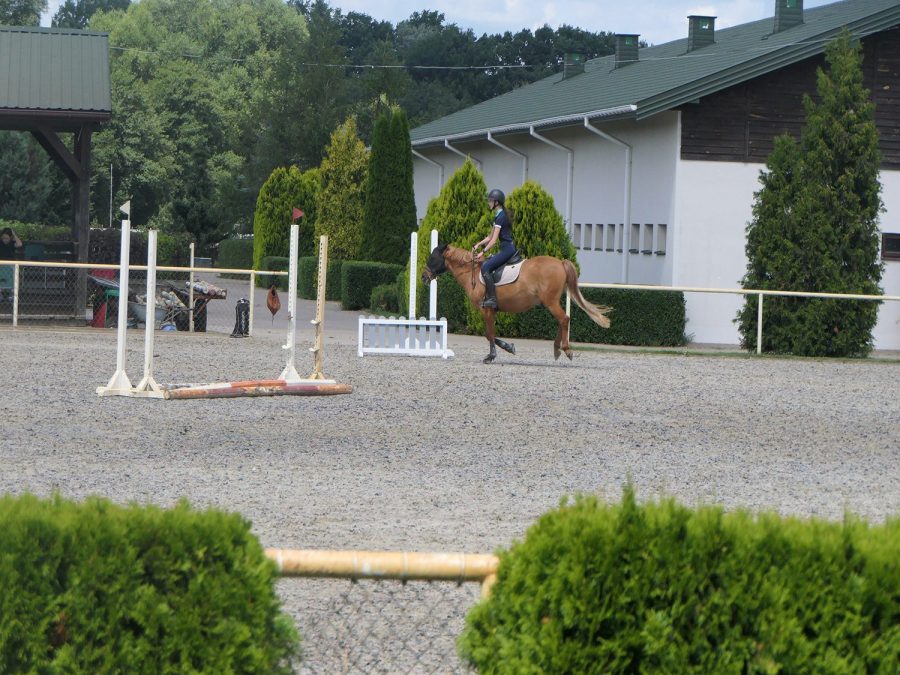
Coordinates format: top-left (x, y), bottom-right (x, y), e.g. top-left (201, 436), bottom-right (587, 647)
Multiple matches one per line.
top-left (422, 244), bottom-right (612, 363)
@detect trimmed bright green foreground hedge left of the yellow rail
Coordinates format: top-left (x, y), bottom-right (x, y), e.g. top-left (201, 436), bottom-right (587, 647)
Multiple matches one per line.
top-left (0, 495), bottom-right (298, 673)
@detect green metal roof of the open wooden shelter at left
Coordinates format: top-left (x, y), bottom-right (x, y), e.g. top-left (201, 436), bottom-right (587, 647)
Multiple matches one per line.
top-left (0, 26), bottom-right (111, 115)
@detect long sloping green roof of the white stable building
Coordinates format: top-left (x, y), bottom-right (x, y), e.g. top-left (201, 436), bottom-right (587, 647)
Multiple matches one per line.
top-left (410, 0), bottom-right (900, 147)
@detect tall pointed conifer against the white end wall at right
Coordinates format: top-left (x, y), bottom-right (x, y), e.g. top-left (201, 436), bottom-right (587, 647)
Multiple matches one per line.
top-left (738, 31), bottom-right (882, 356)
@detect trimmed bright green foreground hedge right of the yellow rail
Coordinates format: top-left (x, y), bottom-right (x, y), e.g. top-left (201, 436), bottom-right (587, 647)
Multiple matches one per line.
top-left (460, 488), bottom-right (900, 675)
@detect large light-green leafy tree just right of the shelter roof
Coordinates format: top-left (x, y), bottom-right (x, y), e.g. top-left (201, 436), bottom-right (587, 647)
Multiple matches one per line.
top-left (90, 0), bottom-right (306, 247)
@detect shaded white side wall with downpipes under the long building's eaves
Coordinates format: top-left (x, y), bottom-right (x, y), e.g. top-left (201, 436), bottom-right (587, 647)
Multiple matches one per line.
top-left (413, 113), bottom-right (679, 284)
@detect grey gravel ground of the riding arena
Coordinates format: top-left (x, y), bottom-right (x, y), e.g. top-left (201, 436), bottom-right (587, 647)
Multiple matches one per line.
top-left (0, 281), bottom-right (900, 673)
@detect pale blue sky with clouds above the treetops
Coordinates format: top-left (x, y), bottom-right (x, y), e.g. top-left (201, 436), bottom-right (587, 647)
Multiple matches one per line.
top-left (41, 0), bottom-right (834, 44)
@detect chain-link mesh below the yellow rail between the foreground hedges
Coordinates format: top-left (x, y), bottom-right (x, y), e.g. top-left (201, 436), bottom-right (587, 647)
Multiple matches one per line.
top-left (278, 578), bottom-right (480, 674)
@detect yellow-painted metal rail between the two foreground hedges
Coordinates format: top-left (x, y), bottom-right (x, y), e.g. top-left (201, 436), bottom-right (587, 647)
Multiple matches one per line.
top-left (266, 548), bottom-right (500, 597)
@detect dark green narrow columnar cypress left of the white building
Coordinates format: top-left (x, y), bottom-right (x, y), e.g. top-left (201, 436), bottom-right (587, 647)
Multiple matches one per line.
top-left (362, 109), bottom-right (416, 265)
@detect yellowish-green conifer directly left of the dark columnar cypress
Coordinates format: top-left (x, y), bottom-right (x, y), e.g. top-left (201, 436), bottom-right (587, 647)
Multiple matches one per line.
top-left (316, 116), bottom-right (369, 260)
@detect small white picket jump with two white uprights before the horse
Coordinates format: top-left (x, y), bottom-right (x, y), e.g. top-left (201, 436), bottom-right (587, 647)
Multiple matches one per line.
top-left (357, 230), bottom-right (453, 359)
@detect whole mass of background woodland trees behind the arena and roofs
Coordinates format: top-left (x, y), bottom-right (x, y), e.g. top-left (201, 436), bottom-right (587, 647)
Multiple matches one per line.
top-left (0, 0), bottom-right (612, 252)
